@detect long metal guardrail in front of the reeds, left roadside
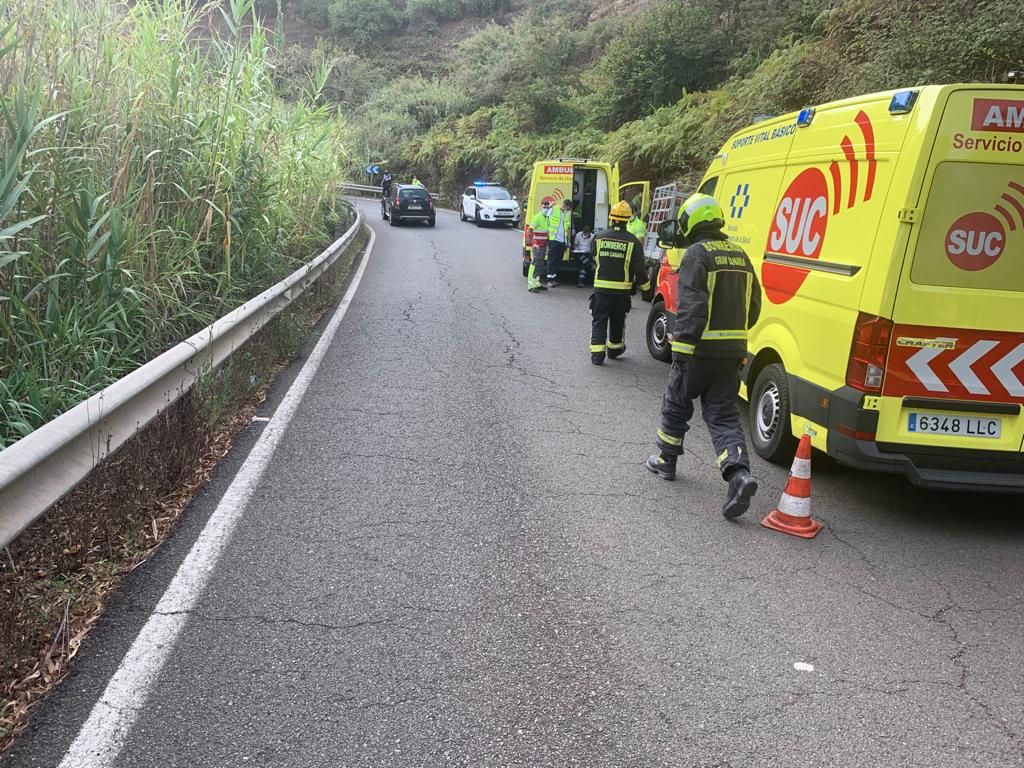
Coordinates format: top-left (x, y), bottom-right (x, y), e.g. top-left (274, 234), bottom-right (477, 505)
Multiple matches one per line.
top-left (0, 206), bottom-right (362, 547)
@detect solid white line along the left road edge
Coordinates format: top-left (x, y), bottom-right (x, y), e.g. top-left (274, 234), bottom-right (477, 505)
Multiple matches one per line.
top-left (59, 229), bottom-right (375, 768)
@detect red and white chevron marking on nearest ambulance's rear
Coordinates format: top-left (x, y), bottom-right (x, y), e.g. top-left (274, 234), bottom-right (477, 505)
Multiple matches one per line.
top-left (882, 326), bottom-right (1024, 402)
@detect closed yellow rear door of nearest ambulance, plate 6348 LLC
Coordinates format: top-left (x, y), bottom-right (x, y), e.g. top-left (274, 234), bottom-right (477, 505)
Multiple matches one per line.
top-left (878, 86), bottom-right (1024, 462)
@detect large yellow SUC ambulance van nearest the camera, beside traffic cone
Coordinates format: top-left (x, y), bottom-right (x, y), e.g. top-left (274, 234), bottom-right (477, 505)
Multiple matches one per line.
top-left (675, 84), bottom-right (1024, 493)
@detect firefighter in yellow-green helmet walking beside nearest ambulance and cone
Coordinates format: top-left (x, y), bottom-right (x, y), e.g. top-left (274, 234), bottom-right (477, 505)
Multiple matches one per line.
top-left (647, 194), bottom-right (761, 519)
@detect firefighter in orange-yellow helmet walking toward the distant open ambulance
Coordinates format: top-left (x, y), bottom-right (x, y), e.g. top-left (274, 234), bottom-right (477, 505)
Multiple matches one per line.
top-left (590, 201), bottom-right (648, 366)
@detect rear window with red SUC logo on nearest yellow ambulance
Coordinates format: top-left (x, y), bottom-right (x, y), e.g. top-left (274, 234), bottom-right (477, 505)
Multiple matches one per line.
top-left (910, 162), bottom-right (1024, 291)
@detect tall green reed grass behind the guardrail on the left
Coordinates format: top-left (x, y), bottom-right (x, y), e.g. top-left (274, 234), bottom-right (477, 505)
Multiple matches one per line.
top-left (0, 0), bottom-right (343, 447)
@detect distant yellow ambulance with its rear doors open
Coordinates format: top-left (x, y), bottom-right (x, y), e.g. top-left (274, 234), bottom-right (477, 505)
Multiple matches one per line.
top-left (522, 158), bottom-right (650, 278)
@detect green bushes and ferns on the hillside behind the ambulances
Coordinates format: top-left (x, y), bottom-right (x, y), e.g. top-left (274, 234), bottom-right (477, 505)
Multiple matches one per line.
top-left (305, 0), bottom-right (1024, 196)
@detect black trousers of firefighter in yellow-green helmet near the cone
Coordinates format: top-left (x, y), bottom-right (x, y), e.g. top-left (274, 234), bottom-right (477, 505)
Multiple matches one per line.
top-left (656, 357), bottom-right (751, 475)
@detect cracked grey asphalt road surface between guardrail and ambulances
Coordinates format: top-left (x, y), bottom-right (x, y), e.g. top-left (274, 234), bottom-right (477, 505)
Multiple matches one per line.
top-left (5, 203), bottom-right (1024, 768)
